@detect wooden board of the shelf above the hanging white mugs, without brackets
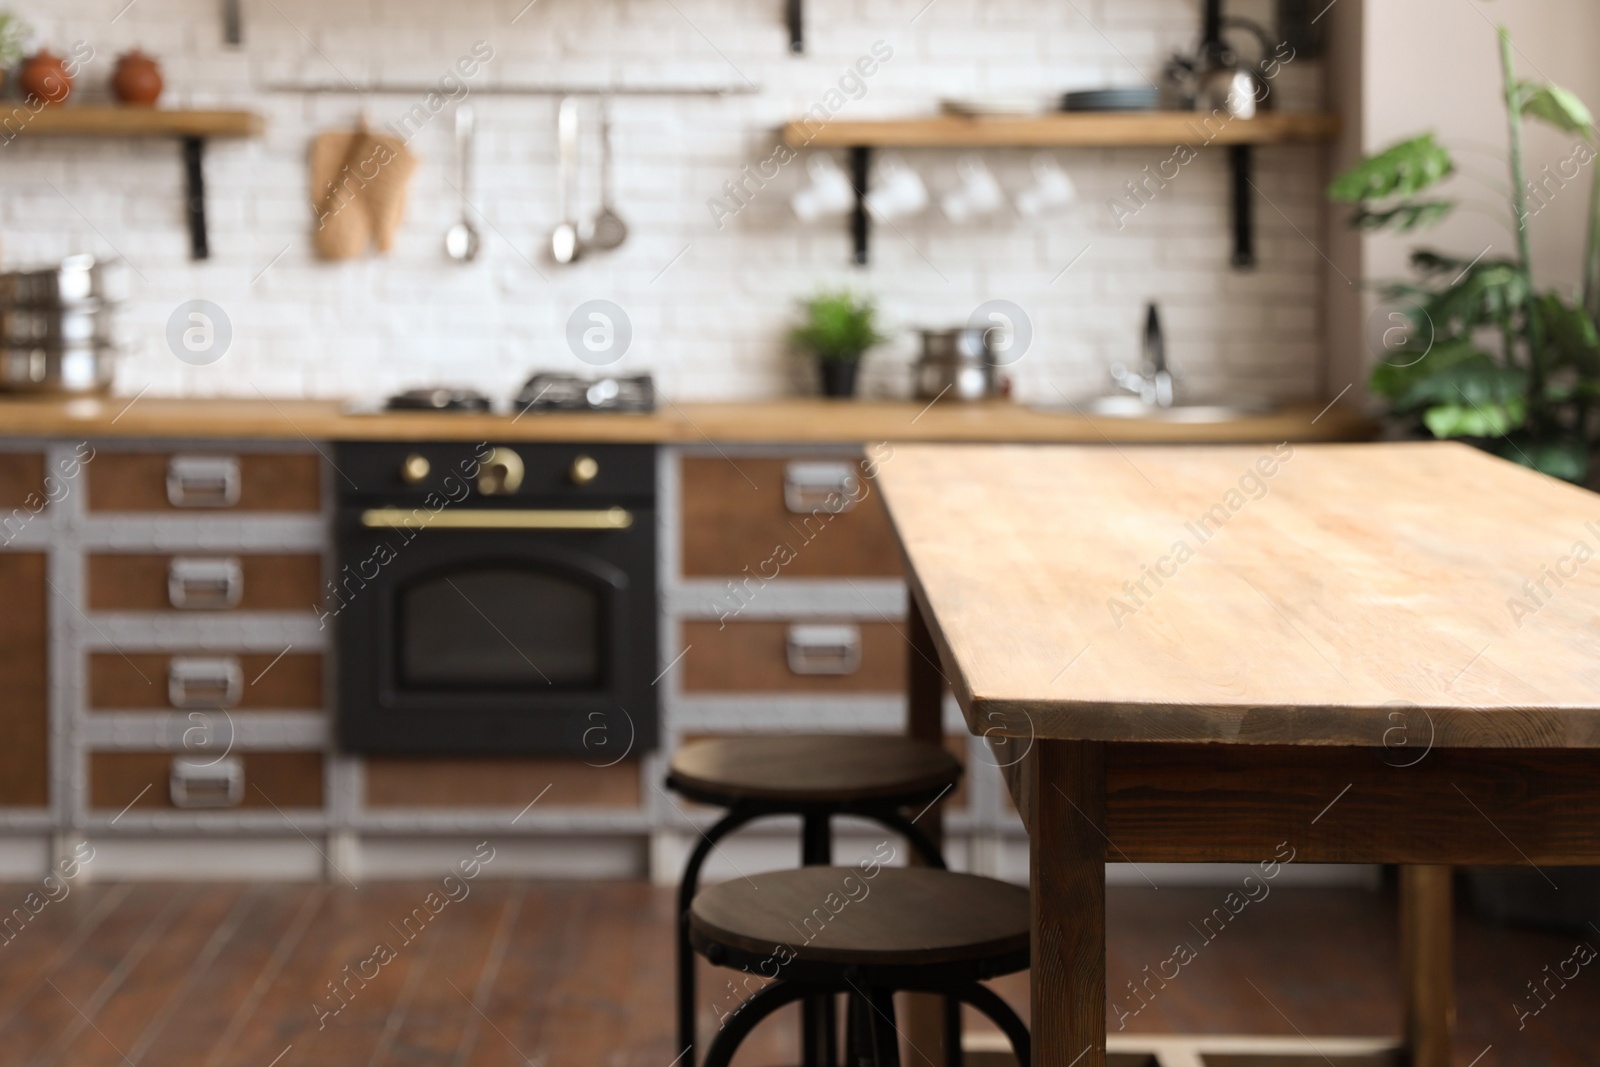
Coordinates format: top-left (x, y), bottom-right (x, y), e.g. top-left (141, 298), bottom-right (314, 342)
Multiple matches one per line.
top-left (784, 110), bottom-right (1339, 149)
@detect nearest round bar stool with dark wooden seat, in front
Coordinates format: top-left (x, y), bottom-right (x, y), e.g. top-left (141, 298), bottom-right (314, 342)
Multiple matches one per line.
top-left (690, 862), bottom-right (1030, 1067)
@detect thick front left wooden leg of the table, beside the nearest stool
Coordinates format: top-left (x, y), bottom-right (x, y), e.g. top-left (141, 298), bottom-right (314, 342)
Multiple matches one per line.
top-left (1029, 741), bottom-right (1106, 1067)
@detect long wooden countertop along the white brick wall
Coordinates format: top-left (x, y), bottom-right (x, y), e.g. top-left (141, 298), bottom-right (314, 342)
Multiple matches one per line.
top-left (0, 397), bottom-right (1374, 445)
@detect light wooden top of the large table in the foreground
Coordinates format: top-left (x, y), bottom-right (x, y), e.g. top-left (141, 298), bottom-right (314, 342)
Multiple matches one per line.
top-left (878, 443), bottom-right (1600, 752)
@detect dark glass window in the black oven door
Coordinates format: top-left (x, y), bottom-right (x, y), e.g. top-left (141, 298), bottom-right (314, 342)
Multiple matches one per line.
top-left (400, 568), bottom-right (603, 689)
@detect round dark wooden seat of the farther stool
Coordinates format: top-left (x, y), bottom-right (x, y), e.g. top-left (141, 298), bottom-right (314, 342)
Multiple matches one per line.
top-left (667, 734), bottom-right (962, 806)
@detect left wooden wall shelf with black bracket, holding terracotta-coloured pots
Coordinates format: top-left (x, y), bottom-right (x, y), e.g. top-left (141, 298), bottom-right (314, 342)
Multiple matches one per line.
top-left (0, 104), bottom-right (266, 259)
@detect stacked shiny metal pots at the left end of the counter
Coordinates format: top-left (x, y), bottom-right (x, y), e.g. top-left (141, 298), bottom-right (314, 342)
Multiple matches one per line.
top-left (0, 256), bottom-right (128, 394)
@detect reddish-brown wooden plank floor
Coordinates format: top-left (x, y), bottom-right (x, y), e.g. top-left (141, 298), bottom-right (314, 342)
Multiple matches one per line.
top-left (0, 880), bottom-right (1600, 1067)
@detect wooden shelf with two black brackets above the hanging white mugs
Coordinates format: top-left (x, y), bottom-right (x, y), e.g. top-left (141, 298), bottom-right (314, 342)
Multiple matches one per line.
top-left (782, 110), bottom-right (1341, 270)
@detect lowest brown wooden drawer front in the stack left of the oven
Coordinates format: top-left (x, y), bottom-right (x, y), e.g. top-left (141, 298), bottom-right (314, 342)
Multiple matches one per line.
top-left (90, 752), bottom-right (322, 809)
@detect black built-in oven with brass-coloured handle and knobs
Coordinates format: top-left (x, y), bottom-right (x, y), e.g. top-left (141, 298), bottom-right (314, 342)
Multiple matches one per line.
top-left (334, 442), bottom-right (658, 763)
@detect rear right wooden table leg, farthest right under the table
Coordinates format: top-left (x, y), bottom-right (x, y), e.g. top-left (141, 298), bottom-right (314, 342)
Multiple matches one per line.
top-left (1400, 865), bottom-right (1456, 1067)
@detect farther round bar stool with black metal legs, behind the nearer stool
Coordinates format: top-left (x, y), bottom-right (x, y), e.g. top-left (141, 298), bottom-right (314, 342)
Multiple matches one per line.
top-left (667, 734), bottom-right (962, 1067)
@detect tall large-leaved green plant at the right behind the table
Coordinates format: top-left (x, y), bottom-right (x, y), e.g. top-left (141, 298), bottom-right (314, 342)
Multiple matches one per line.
top-left (1328, 27), bottom-right (1600, 483)
